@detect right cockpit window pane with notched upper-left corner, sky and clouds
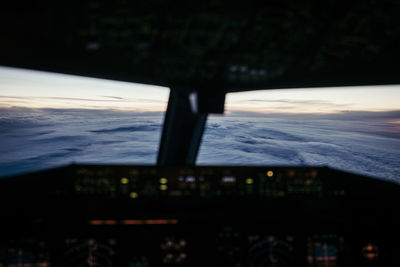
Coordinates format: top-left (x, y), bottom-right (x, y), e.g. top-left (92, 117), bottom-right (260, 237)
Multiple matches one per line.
top-left (197, 86), bottom-right (400, 181)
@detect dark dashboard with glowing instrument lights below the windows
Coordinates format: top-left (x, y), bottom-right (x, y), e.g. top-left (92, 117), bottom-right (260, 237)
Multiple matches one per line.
top-left (0, 165), bottom-right (400, 266)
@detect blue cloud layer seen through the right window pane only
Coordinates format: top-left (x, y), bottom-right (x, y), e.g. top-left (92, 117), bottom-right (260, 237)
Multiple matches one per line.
top-left (198, 112), bottom-right (400, 182)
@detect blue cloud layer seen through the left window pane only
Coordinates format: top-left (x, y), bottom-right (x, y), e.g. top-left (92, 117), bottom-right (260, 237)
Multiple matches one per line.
top-left (0, 109), bottom-right (163, 176)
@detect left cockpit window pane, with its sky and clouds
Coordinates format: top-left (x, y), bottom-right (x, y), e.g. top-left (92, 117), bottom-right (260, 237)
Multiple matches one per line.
top-left (0, 67), bottom-right (169, 177)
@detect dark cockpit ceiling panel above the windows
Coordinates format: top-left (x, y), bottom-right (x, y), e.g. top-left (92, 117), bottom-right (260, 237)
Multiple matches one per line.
top-left (0, 0), bottom-right (400, 91)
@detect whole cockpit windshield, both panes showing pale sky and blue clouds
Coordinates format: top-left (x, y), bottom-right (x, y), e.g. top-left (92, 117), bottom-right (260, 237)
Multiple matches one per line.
top-left (0, 68), bottom-right (400, 181)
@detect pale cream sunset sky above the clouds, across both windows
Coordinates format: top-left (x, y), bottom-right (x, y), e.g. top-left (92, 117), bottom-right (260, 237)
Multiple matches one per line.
top-left (0, 67), bottom-right (400, 113)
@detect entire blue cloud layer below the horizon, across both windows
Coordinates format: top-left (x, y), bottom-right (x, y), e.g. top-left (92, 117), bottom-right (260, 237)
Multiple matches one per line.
top-left (0, 108), bottom-right (400, 182)
